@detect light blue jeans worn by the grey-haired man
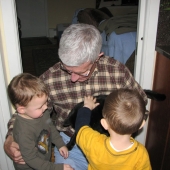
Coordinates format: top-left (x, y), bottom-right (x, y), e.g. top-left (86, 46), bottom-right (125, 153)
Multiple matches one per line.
top-left (54, 132), bottom-right (88, 170)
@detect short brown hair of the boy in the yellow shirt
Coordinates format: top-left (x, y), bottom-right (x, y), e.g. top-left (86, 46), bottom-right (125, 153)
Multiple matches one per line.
top-left (103, 89), bottom-right (146, 135)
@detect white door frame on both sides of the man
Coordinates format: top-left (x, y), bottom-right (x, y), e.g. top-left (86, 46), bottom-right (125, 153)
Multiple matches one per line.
top-left (0, 0), bottom-right (160, 170)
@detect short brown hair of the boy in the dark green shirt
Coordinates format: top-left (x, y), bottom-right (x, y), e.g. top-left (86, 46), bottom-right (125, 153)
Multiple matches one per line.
top-left (8, 73), bottom-right (48, 107)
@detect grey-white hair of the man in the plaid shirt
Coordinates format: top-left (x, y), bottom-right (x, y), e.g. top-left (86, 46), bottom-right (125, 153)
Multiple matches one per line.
top-left (58, 24), bottom-right (102, 66)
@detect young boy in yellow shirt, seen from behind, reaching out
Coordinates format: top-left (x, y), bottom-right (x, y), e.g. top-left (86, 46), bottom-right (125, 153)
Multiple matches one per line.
top-left (75, 89), bottom-right (151, 170)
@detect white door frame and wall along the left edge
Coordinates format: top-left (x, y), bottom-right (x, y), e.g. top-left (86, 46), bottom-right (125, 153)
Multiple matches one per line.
top-left (0, 0), bottom-right (22, 170)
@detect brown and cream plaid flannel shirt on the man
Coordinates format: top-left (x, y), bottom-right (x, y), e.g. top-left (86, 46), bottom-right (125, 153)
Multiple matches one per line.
top-left (6, 56), bottom-right (147, 136)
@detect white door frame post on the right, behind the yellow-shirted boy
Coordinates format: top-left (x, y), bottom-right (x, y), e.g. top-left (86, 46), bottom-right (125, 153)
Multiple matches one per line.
top-left (135, 0), bottom-right (160, 145)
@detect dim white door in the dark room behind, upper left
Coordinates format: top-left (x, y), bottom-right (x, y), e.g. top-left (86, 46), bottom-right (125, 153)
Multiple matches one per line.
top-left (16, 0), bottom-right (48, 38)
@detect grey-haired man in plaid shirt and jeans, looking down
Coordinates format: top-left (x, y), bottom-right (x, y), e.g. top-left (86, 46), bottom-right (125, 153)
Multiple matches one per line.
top-left (4, 24), bottom-right (147, 170)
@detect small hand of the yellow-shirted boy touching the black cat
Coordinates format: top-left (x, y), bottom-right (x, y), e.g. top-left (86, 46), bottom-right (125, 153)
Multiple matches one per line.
top-left (84, 96), bottom-right (99, 110)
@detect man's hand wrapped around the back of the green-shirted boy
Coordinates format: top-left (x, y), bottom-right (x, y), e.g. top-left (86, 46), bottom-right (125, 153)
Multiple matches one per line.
top-left (4, 135), bottom-right (25, 164)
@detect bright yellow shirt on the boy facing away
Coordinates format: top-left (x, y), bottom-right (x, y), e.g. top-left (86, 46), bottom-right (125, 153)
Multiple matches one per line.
top-left (76, 126), bottom-right (152, 170)
